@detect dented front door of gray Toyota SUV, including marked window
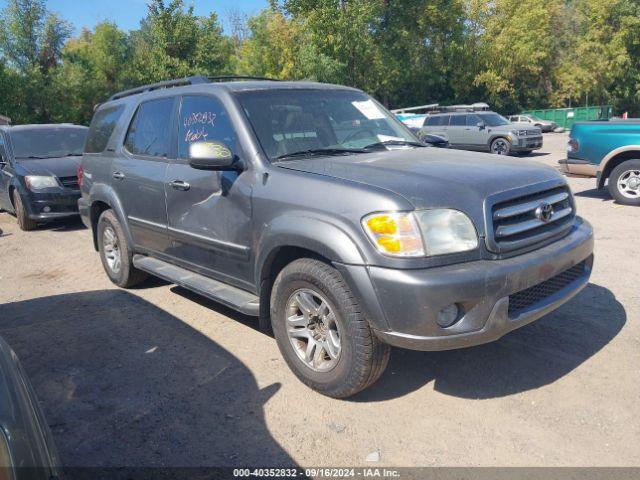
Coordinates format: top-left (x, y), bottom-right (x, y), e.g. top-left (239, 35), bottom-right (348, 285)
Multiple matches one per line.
top-left (165, 95), bottom-right (253, 287)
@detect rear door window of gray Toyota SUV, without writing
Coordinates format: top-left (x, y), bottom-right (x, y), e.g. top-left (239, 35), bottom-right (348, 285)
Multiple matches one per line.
top-left (124, 97), bottom-right (174, 157)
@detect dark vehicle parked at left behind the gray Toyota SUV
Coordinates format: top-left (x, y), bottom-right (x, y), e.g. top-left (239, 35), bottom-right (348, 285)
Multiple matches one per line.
top-left (0, 124), bottom-right (88, 230)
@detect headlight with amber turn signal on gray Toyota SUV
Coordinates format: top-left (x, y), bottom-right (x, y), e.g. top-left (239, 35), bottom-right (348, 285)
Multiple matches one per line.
top-left (362, 208), bottom-right (478, 257)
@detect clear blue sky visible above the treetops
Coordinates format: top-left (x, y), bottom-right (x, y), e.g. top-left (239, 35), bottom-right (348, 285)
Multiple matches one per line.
top-left (0, 0), bottom-right (268, 34)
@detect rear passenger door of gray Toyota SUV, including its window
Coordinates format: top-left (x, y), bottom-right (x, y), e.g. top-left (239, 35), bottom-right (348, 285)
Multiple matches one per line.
top-left (111, 97), bottom-right (176, 252)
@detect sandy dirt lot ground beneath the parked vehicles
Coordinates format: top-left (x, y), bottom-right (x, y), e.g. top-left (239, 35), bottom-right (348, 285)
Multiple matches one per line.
top-left (0, 134), bottom-right (640, 467)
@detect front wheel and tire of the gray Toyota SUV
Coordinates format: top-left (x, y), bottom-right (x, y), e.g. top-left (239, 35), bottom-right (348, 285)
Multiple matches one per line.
top-left (271, 258), bottom-right (391, 398)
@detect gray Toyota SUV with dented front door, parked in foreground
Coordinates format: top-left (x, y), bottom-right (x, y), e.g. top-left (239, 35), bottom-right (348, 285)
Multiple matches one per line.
top-left (79, 77), bottom-right (593, 397)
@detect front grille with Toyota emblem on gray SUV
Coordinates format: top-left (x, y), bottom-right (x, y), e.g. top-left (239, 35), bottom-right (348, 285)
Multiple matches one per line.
top-left (487, 185), bottom-right (575, 252)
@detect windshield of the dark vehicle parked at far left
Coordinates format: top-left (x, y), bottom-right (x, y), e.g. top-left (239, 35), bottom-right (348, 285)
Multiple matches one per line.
top-left (11, 127), bottom-right (87, 158)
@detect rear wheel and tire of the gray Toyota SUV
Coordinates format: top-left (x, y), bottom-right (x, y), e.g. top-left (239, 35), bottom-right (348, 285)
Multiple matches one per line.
top-left (97, 210), bottom-right (147, 288)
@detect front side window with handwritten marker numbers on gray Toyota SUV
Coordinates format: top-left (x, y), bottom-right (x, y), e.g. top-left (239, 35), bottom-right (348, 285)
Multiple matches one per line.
top-left (178, 95), bottom-right (236, 158)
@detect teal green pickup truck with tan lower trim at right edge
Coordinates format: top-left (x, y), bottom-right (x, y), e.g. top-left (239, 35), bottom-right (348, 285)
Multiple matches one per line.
top-left (559, 119), bottom-right (640, 206)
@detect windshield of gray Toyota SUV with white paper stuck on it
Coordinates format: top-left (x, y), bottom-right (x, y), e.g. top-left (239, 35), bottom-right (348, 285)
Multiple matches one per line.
top-left (237, 89), bottom-right (419, 160)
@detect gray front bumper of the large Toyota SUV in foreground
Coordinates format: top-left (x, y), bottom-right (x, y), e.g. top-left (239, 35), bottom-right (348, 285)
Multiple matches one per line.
top-left (342, 218), bottom-right (593, 350)
